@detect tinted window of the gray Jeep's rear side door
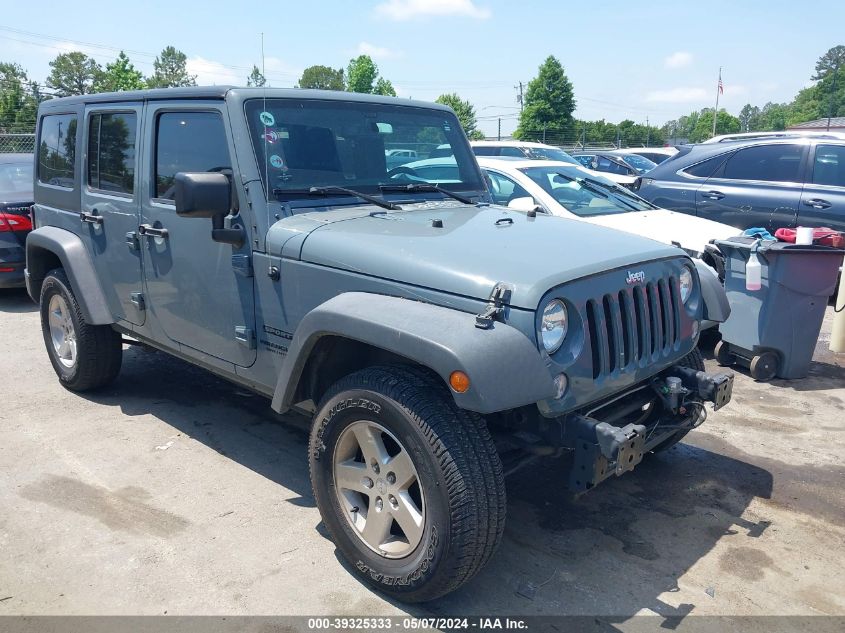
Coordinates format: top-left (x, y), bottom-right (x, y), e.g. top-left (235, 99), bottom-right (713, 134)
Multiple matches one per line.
top-left (87, 112), bottom-right (138, 195)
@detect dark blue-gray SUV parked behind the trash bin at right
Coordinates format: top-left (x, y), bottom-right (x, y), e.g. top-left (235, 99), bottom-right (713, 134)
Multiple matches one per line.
top-left (636, 137), bottom-right (845, 231)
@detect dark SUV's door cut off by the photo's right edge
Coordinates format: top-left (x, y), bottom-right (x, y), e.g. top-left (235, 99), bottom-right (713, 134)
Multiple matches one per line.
top-left (798, 143), bottom-right (845, 231)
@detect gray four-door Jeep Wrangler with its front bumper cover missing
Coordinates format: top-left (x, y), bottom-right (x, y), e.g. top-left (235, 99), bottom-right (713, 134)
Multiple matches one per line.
top-left (26, 87), bottom-right (732, 601)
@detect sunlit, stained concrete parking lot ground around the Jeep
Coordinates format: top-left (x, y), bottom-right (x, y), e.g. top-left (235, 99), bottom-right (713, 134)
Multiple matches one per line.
top-left (0, 291), bottom-right (845, 616)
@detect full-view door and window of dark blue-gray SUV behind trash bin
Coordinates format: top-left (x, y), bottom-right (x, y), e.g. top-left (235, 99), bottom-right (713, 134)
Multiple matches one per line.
top-left (695, 143), bottom-right (808, 232)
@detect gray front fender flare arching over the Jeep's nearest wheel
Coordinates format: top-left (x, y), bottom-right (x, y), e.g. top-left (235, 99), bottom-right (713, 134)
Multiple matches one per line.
top-left (272, 292), bottom-right (555, 414)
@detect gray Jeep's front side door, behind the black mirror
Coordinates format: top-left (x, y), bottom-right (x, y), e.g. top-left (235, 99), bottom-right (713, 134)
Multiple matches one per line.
top-left (139, 102), bottom-right (256, 366)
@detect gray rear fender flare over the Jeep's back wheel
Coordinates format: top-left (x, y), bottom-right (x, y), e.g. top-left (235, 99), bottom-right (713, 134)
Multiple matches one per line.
top-left (26, 226), bottom-right (114, 325)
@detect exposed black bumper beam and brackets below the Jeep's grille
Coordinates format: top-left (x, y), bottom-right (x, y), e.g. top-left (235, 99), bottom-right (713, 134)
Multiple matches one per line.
top-left (566, 367), bottom-right (733, 493)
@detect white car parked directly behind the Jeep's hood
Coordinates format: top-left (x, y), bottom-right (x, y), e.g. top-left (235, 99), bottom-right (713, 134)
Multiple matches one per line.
top-left (477, 158), bottom-right (739, 266)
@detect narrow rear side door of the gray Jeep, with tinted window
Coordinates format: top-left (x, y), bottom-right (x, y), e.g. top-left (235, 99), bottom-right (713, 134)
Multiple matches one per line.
top-left (79, 103), bottom-right (145, 325)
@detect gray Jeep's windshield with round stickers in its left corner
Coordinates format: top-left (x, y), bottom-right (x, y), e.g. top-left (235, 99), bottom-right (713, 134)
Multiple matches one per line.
top-left (245, 99), bottom-right (485, 205)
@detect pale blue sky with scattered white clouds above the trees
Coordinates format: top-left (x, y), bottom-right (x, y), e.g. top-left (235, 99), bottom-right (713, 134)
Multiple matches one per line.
top-left (0, 0), bottom-right (845, 135)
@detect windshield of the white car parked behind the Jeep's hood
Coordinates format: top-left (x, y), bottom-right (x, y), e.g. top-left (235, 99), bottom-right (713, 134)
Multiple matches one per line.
top-left (520, 167), bottom-right (657, 217)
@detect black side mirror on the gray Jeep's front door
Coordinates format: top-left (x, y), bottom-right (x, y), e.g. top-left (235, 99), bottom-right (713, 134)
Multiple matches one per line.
top-left (174, 172), bottom-right (246, 248)
